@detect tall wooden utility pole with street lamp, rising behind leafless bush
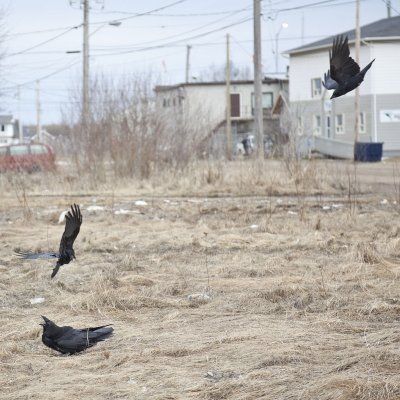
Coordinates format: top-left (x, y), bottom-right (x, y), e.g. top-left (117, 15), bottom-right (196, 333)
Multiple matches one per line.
top-left (82, 0), bottom-right (89, 134)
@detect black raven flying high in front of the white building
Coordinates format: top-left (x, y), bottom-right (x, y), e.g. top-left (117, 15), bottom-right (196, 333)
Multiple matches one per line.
top-left (322, 36), bottom-right (375, 99)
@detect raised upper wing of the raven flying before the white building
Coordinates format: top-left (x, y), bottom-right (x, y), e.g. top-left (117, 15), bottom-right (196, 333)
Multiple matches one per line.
top-left (329, 36), bottom-right (360, 85)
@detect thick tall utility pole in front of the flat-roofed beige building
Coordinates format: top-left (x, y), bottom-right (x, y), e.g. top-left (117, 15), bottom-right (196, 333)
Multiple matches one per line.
top-left (253, 0), bottom-right (264, 160)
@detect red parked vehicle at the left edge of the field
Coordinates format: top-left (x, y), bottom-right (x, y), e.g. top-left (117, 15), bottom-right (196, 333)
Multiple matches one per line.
top-left (0, 143), bottom-right (55, 172)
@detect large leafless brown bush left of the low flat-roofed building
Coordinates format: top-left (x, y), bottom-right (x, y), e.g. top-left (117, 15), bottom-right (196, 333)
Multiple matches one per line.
top-left (61, 76), bottom-right (210, 180)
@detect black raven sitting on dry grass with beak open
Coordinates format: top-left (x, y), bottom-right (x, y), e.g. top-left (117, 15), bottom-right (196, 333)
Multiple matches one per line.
top-left (40, 315), bottom-right (114, 354)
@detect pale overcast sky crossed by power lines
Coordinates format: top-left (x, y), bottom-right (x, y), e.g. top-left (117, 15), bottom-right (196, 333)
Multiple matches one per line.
top-left (0, 0), bottom-right (400, 124)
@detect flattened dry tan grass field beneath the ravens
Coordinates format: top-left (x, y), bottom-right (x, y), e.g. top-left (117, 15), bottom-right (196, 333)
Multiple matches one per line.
top-left (0, 160), bottom-right (400, 400)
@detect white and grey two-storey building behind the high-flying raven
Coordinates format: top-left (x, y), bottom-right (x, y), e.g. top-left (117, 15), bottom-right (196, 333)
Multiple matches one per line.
top-left (288, 16), bottom-right (400, 158)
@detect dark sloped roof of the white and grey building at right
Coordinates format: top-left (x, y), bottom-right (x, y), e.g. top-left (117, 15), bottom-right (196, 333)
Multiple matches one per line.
top-left (286, 16), bottom-right (400, 54)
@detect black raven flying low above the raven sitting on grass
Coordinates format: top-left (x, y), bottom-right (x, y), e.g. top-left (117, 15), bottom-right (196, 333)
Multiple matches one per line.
top-left (16, 204), bottom-right (82, 278)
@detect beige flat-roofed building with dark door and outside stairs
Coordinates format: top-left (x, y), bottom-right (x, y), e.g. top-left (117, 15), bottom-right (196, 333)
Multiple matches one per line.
top-left (155, 76), bottom-right (288, 155)
